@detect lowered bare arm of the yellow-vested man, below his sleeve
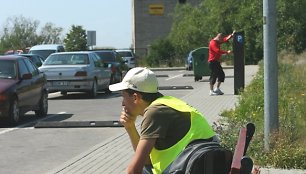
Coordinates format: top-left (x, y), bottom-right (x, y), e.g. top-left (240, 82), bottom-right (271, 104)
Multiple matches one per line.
top-left (127, 138), bottom-right (156, 174)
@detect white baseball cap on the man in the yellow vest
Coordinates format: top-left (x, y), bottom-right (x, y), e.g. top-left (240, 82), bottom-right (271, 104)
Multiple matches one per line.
top-left (109, 67), bottom-right (158, 93)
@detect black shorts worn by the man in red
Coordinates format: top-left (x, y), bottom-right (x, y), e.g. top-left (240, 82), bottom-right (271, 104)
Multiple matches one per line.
top-left (208, 61), bottom-right (225, 85)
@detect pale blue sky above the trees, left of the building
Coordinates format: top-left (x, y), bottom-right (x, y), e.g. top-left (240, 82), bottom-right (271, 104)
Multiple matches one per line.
top-left (0, 0), bottom-right (132, 49)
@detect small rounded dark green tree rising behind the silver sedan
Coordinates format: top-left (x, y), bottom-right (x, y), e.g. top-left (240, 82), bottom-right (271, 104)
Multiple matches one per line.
top-left (64, 25), bottom-right (87, 51)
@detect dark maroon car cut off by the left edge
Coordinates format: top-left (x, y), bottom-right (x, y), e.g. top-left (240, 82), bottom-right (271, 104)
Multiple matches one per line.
top-left (0, 55), bottom-right (48, 125)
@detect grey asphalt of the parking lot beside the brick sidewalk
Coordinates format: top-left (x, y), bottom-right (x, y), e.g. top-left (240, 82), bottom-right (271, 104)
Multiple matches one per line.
top-left (0, 70), bottom-right (208, 174)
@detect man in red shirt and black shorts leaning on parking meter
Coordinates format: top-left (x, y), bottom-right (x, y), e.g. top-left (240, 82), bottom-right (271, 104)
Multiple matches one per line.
top-left (208, 31), bottom-right (235, 95)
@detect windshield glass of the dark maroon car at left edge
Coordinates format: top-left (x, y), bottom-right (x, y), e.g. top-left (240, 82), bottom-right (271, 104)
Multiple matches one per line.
top-left (0, 60), bottom-right (17, 79)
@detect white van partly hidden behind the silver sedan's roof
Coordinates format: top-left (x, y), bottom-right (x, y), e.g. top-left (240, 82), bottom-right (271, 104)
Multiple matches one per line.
top-left (29, 44), bottom-right (65, 60)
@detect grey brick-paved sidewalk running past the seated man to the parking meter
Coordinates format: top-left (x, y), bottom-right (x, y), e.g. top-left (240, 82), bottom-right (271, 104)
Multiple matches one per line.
top-left (48, 66), bottom-right (306, 174)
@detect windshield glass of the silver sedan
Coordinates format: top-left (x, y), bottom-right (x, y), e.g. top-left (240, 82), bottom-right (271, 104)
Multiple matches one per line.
top-left (44, 54), bottom-right (89, 65)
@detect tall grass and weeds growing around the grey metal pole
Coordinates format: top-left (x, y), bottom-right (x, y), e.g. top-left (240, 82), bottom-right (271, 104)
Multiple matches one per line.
top-left (216, 53), bottom-right (306, 169)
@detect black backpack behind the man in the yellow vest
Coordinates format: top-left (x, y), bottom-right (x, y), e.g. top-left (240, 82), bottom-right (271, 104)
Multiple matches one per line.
top-left (169, 140), bottom-right (233, 174)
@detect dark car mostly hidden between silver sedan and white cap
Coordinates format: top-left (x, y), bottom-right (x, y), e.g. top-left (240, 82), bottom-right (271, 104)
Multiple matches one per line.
top-left (92, 50), bottom-right (127, 84)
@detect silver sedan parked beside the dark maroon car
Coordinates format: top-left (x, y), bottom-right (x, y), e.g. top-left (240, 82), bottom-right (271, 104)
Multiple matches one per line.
top-left (39, 51), bottom-right (111, 98)
